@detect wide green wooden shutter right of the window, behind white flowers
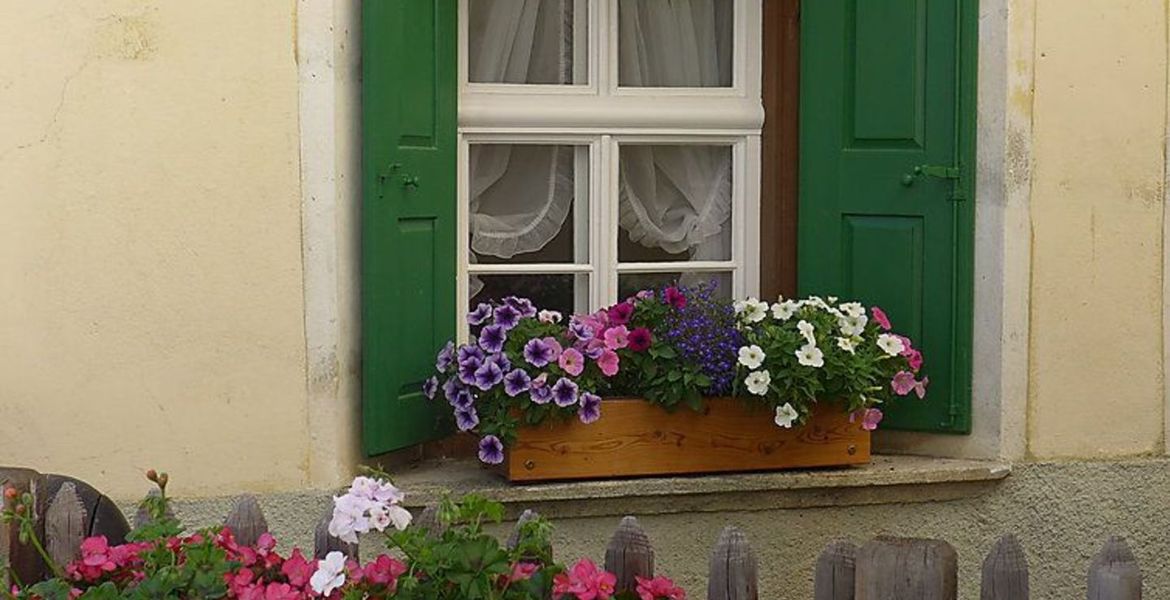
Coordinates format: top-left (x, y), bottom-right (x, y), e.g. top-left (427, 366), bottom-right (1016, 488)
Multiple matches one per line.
top-left (798, 0), bottom-right (976, 433)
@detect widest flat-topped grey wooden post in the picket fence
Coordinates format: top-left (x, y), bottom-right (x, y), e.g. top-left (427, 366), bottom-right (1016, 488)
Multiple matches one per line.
top-left (854, 537), bottom-right (958, 600)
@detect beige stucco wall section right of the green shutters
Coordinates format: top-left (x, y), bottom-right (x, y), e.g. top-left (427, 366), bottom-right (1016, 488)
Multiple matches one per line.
top-left (1019, 0), bottom-right (1166, 457)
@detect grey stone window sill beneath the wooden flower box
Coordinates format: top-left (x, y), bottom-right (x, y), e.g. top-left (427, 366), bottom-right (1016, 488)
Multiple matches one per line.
top-left (394, 455), bottom-right (1011, 518)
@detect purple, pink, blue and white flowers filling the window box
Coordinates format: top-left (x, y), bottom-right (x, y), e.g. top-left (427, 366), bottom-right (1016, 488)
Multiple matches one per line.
top-left (424, 283), bottom-right (928, 464)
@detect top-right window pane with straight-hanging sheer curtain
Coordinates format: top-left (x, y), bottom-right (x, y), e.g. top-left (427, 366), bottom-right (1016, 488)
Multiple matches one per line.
top-left (618, 0), bottom-right (735, 88)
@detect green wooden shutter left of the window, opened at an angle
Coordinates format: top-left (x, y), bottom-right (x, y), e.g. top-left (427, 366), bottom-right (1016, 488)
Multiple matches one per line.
top-left (362, 0), bottom-right (457, 454)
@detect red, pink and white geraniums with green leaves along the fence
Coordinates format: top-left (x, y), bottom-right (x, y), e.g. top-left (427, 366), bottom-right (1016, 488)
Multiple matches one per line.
top-left (0, 476), bottom-right (686, 600)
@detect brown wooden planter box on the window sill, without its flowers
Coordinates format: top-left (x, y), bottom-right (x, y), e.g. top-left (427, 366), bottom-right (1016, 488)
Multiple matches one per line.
top-left (501, 398), bottom-right (869, 482)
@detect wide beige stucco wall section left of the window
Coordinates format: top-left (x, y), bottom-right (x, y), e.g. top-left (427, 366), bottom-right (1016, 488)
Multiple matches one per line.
top-left (0, 0), bottom-right (308, 497)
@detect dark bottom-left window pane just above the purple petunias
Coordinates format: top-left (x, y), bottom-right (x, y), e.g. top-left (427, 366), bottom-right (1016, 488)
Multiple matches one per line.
top-left (469, 275), bottom-right (589, 316)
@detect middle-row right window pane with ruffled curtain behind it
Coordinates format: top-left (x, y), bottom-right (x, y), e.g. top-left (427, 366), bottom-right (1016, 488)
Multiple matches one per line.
top-left (618, 145), bottom-right (732, 262)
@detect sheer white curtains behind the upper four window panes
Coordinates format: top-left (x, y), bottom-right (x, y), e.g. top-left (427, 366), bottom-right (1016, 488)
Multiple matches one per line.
top-left (469, 0), bottom-right (732, 267)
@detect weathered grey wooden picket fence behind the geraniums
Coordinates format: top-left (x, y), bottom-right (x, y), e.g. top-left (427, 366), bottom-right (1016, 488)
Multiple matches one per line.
top-left (0, 468), bottom-right (1142, 600)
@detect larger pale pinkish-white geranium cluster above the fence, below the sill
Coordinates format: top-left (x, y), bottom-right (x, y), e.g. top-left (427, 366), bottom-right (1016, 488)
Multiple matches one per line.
top-left (329, 477), bottom-right (412, 544)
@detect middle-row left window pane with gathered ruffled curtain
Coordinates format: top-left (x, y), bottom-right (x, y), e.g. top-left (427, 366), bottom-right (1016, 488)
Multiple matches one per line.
top-left (468, 144), bottom-right (590, 264)
